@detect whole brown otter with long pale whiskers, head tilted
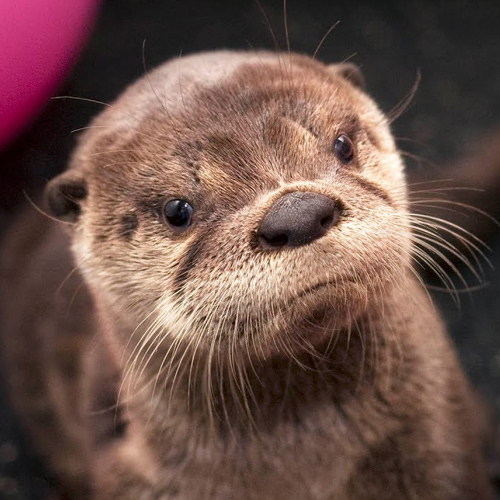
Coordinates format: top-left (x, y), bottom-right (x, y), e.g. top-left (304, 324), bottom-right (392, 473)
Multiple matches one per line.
top-left (2, 51), bottom-right (493, 500)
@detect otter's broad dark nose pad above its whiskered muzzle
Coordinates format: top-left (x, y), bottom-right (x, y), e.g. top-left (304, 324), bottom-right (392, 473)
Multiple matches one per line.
top-left (257, 191), bottom-right (340, 248)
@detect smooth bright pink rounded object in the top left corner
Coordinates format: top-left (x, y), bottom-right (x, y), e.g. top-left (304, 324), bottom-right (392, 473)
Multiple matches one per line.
top-left (0, 0), bottom-right (101, 148)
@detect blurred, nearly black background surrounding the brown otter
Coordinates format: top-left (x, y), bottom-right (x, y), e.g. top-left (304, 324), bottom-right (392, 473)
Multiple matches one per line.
top-left (0, 0), bottom-right (500, 500)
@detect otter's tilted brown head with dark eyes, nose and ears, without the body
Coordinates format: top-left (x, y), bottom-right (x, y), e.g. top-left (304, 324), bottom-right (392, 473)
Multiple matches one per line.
top-left (45, 52), bottom-right (410, 362)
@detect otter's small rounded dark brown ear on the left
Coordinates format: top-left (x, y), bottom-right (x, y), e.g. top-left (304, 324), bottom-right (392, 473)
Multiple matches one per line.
top-left (45, 170), bottom-right (87, 222)
